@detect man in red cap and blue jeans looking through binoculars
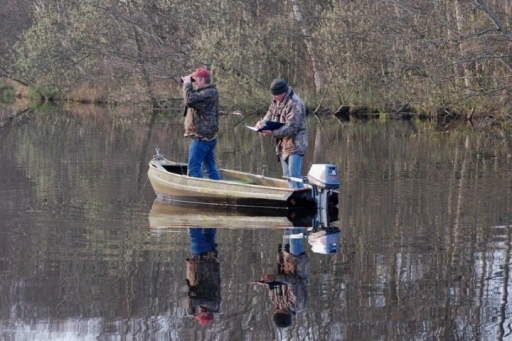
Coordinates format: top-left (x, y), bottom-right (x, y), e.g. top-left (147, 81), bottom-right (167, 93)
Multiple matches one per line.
top-left (182, 68), bottom-right (220, 180)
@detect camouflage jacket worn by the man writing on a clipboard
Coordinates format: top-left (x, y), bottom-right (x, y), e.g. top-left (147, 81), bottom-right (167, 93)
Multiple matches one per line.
top-left (263, 87), bottom-right (308, 159)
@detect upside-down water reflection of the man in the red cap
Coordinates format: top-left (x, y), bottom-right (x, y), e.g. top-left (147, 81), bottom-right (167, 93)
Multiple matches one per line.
top-left (185, 228), bottom-right (221, 325)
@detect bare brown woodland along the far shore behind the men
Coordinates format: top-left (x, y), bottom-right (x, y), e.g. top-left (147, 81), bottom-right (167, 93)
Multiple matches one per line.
top-left (0, 0), bottom-right (512, 125)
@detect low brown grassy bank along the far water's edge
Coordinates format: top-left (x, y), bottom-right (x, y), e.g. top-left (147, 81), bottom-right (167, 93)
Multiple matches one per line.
top-left (0, 76), bottom-right (512, 131)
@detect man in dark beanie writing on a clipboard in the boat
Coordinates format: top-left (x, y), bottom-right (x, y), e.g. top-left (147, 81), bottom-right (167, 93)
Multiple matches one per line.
top-left (256, 79), bottom-right (308, 188)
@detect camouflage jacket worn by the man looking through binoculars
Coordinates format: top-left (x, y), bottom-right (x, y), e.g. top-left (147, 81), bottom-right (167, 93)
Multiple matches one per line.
top-left (183, 83), bottom-right (219, 140)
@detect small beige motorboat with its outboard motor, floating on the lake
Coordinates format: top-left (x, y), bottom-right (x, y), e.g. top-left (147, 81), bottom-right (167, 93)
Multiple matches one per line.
top-left (148, 151), bottom-right (340, 208)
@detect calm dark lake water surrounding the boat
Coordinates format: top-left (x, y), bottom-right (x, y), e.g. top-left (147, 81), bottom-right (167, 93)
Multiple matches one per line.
top-left (0, 108), bottom-right (512, 341)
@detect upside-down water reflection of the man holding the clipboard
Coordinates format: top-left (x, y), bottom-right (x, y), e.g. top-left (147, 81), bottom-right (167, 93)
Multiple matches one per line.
top-left (258, 228), bottom-right (309, 328)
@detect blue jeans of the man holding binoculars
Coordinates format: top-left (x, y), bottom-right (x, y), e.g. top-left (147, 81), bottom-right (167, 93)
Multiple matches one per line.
top-left (188, 139), bottom-right (220, 180)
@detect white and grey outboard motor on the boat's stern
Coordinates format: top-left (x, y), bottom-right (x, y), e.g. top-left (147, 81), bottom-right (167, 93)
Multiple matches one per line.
top-left (307, 164), bottom-right (340, 209)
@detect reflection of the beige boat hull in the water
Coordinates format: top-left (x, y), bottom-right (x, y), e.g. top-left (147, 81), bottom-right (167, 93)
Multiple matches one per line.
top-left (149, 198), bottom-right (317, 229)
